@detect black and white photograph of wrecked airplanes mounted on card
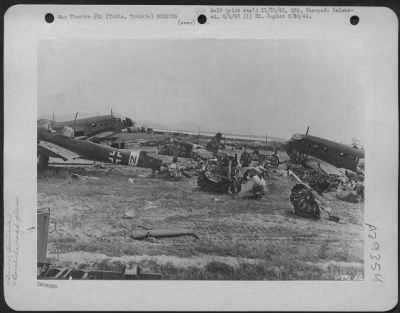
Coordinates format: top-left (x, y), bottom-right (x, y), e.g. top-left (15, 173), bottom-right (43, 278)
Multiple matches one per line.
top-left (37, 39), bottom-right (368, 280)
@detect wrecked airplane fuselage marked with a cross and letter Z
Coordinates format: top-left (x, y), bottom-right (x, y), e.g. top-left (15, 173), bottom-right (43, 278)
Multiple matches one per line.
top-left (37, 123), bottom-right (162, 171)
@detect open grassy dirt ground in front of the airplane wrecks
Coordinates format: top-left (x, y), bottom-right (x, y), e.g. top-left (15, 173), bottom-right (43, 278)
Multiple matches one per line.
top-left (38, 143), bottom-right (364, 280)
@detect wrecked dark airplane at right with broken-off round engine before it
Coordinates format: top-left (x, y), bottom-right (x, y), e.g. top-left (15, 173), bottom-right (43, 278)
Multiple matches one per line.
top-left (286, 129), bottom-right (365, 221)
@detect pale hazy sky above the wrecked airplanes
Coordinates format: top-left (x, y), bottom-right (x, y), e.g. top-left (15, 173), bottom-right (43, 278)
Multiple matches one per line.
top-left (38, 39), bottom-right (365, 143)
